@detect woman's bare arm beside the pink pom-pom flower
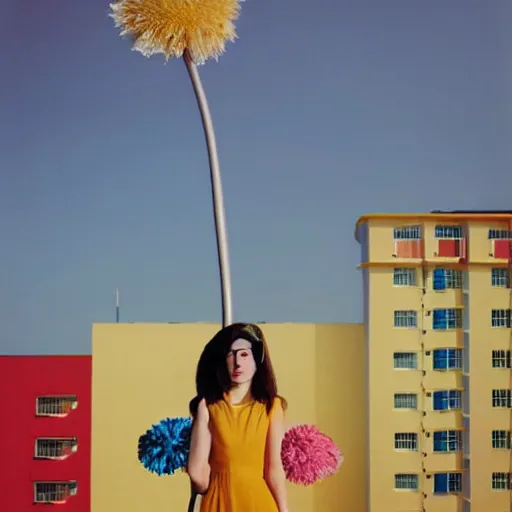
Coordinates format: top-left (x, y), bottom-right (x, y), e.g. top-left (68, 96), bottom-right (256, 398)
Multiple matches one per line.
top-left (264, 398), bottom-right (288, 512)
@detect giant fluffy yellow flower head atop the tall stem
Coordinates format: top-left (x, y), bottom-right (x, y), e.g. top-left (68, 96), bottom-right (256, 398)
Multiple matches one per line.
top-left (110, 0), bottom-right (240, 64)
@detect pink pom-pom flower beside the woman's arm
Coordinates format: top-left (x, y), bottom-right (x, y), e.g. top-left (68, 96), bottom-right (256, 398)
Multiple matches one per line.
top-left (281, 425), bottom-right (343, 486)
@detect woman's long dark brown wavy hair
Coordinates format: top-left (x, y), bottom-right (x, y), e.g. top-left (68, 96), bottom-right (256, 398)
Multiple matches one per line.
top-left (190, 323), bottom-right (286, 416)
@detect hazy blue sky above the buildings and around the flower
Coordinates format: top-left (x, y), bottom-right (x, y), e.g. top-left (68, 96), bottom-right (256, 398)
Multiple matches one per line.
top-left (0, 0), bottom-right (512, 354)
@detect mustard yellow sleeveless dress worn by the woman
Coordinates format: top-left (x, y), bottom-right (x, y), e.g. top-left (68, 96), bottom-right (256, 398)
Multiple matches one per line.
top-left (200, 397), bottom-right (280, 512)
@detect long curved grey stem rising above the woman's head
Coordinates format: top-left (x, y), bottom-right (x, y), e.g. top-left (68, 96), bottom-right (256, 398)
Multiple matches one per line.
top-left (183, 50), bottom-right (233, 327)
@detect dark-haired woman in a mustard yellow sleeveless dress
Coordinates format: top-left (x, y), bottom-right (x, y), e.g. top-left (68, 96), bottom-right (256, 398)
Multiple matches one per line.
top-left (187, 324), bottom-right (288, 512)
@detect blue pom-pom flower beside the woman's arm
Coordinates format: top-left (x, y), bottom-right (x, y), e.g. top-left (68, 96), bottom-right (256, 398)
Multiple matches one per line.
top-left (138, 418), bottom-right (192, 476)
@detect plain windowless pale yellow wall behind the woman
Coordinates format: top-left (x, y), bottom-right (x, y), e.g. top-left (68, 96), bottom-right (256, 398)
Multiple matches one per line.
top-left (91, 324), bottom-right (366, 512)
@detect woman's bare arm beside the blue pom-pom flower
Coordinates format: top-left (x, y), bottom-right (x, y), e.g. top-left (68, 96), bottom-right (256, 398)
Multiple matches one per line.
top-left (187, 399), bottom-right (212, 494)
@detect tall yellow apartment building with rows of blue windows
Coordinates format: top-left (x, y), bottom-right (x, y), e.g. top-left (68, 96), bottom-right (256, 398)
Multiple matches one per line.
top-left (356, 211), bottom-right (512, 512)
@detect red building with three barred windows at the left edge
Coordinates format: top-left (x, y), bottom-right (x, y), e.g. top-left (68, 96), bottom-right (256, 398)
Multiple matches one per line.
top-left (0, 356), bottom-right (92, 512)
